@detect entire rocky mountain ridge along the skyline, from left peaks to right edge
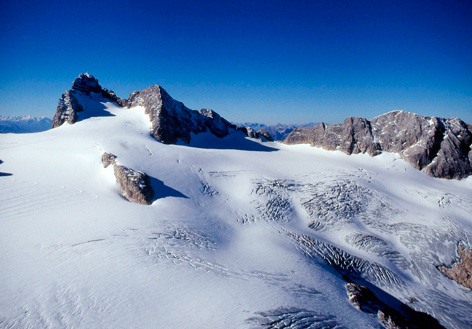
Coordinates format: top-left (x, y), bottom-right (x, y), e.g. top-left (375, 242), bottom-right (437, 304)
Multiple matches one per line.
top-left (52, 73), bottom-right (472, 179)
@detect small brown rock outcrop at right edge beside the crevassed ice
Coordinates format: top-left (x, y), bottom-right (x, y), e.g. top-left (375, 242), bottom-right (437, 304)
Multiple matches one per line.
top-left (438, 244), bottom-right (472, 289)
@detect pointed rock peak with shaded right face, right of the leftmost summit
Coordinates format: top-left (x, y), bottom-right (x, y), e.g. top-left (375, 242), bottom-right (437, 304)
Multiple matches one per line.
top-left (123, 85), bottom-right (234, 144)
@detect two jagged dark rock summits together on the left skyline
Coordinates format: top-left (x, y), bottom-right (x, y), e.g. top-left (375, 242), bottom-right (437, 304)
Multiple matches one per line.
top-left (52, 73), bottom-right (247, 144)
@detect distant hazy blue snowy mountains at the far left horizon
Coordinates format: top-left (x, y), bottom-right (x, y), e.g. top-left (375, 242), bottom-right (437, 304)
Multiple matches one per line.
top-left (0, 115), bottom-right (51, 134)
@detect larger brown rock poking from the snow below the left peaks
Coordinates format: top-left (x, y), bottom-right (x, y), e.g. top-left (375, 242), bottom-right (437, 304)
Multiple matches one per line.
top-left (114, 164), bottom-right (154, 204)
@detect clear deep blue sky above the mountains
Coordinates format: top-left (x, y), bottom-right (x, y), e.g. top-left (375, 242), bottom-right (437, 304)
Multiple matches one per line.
top-left (0, 0), bottom-right (472, 123)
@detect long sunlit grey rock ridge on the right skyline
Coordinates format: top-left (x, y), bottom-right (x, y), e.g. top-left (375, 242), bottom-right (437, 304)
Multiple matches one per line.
top-left (284, 111), bottom-right (472, 179)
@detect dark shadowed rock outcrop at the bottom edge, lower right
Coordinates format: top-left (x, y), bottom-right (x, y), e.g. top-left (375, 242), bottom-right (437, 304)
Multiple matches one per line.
top-left (345, 283), bottom-right (444, 329)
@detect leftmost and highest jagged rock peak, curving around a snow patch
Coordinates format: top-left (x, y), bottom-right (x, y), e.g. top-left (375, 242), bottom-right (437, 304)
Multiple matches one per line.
top-left (51, 73), bottom-right (127, 128)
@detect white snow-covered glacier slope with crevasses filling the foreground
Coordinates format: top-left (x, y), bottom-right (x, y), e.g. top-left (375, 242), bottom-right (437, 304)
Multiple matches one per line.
top-left (0, 95), bottom-right (472, 328)
